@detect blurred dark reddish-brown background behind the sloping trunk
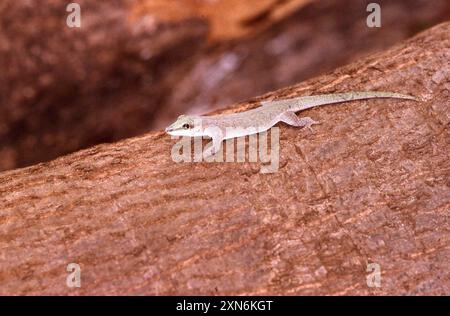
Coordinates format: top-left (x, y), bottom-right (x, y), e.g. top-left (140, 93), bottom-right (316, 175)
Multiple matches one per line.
top-left (0, 0), bottom-right (450, 171)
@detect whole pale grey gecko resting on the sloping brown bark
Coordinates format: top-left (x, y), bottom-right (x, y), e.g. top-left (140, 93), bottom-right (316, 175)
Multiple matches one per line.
top-left (165, 91), bottom-right (418, 157)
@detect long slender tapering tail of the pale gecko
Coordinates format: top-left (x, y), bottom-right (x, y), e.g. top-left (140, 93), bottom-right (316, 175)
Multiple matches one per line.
top-left (274, 91), bottom-right (418, 112)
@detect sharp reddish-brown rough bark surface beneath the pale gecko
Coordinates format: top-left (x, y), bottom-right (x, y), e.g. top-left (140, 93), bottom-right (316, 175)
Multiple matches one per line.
top-left (0, 23), bottom-right (450, 295)
